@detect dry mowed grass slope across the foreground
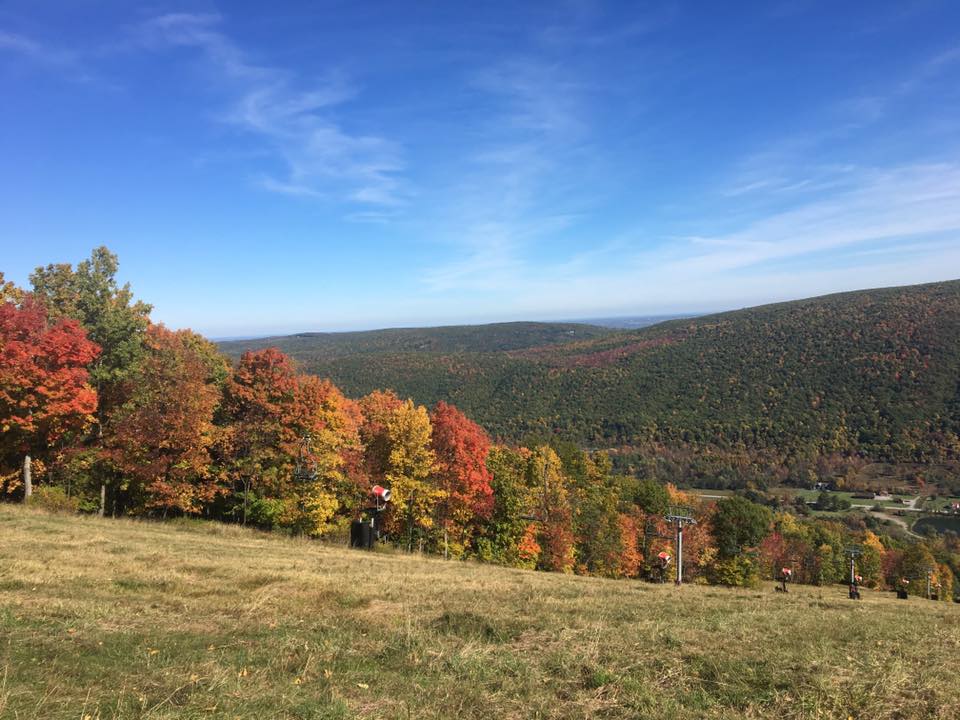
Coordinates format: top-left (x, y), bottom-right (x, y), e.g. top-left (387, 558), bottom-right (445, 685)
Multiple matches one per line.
top-left (0, 505), bottom-right (960, 720)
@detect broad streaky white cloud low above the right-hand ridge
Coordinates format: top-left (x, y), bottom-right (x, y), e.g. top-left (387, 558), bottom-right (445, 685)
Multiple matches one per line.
top-left (414, 163), bottom-right (960, 318)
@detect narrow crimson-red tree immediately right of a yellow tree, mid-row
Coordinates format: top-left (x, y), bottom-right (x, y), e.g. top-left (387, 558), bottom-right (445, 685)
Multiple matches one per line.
top-left (430, 401), bottom-right (493, 548)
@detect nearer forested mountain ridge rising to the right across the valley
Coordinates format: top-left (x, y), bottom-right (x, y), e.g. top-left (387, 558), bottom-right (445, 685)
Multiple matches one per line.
top-left (222, 281), bottom-right (960, 484)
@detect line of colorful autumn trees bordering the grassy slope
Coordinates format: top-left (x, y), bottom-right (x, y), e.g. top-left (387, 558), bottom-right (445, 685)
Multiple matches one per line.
top-left (0, 247), bottom-right (960, 598)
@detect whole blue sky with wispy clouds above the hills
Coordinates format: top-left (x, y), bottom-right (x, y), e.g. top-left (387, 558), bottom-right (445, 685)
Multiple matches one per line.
top-left (0, 0), bottom-right (960, 336)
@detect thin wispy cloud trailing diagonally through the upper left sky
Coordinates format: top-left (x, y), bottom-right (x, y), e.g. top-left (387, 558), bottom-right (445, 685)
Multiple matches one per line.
top-left (138, 13), bottom-right (410, 207)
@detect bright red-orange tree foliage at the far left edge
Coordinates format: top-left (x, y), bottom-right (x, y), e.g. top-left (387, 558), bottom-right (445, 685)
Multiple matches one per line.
top-left (0, 297), bottom-right (100, 492)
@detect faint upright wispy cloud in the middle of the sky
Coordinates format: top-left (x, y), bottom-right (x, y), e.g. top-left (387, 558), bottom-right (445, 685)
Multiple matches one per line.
top-left (422, 55), bottom-right (589, 293)
